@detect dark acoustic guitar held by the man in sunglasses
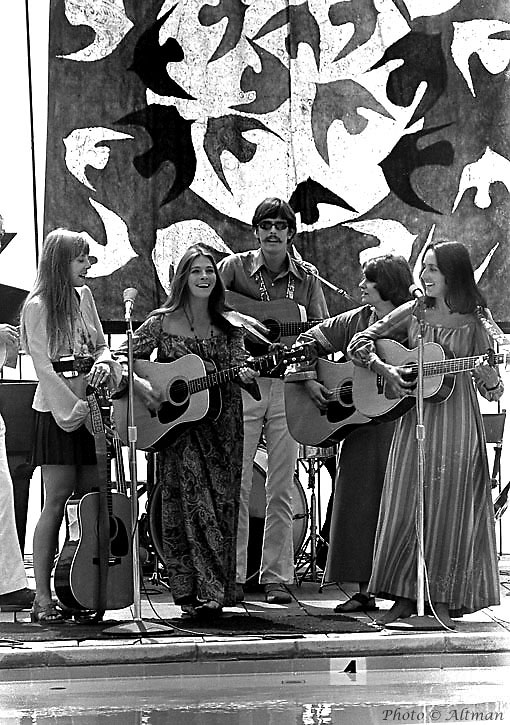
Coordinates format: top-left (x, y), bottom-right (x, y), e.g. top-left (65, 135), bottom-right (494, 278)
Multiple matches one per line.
top-left (225, 290), bottom-right (322, 351)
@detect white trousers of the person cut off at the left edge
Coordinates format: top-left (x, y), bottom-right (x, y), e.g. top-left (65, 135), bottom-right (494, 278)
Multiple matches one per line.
top-left (0, 415), bottom-right (27, 594)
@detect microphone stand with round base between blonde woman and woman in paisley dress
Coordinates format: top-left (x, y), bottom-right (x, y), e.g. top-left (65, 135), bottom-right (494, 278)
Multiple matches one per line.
top-left (103, 309), bottom-right (175, 636)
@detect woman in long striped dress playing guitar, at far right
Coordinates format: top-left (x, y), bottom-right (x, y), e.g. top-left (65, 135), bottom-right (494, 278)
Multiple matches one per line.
top-left (348, 242), bottom-right (503, 628)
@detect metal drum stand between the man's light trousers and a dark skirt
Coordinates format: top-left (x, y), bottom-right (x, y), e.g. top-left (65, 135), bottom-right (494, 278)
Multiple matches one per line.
top-left (295, 445), bottom-right (336, 586)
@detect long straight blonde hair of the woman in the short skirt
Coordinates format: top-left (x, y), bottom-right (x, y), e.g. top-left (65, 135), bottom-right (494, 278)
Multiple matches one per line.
top-left (21, 229), bottom-right (89, 357)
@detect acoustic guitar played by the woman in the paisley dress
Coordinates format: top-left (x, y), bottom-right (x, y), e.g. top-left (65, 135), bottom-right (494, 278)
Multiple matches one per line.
top-left (113, 345), bottom-right (312, 451)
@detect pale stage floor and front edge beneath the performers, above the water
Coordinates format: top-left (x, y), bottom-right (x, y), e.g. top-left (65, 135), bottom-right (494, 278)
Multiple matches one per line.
top-left (0, 556), bottom-right (510, 681)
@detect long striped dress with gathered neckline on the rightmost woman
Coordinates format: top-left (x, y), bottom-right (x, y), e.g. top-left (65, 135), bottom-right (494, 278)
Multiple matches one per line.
top-left (349, 303), bottom-right (499, 616)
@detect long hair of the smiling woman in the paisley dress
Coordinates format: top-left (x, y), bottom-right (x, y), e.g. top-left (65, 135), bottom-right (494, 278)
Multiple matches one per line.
top-left (149, 244), bottom-right (233, 333)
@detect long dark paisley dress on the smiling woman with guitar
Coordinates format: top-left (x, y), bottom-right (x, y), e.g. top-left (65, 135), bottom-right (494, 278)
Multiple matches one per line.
top-left (127, 315), bottom-right (247, 606)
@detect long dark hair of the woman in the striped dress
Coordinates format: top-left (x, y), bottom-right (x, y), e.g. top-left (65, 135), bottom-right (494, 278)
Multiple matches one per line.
top-left (423, 241), bottom-right (487, 315)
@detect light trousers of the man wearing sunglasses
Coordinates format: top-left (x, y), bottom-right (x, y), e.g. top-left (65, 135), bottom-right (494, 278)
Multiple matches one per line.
top-left (236, 378), bottom-right (298, 584)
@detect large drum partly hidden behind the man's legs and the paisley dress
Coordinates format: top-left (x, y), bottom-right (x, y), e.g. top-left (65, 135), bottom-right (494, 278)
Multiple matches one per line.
top-left (147, 448), bottom-right (308, 579)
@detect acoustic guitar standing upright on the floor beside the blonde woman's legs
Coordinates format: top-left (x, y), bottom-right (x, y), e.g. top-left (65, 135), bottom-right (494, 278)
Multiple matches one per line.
top-left (54, 390), bottom-right (134, 612)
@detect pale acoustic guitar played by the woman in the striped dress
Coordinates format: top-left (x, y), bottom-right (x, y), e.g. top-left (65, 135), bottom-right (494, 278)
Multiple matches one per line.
top-left (353, 340), bottom-right (510, 421)
